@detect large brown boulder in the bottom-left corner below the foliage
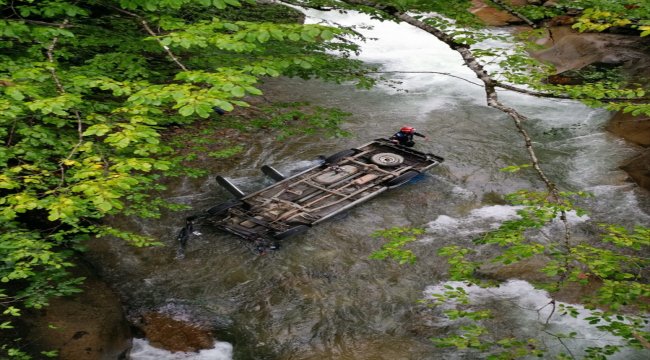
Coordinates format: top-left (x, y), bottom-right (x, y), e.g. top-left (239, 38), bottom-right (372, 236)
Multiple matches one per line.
top-left (23, 261), bottom-right (132, 360)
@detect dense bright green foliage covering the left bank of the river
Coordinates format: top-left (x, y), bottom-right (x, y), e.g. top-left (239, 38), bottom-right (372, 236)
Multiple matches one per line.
top-left (0, 0), bottom-right (373, 357)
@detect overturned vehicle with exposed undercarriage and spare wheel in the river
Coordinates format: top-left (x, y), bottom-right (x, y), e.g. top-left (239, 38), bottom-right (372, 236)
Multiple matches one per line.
top-left (178, 139), bottom-right (444, 252)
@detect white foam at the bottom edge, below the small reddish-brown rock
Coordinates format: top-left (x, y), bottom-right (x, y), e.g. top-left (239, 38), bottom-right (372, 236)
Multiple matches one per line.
top-left (129, 339), bottom-right (232, 360)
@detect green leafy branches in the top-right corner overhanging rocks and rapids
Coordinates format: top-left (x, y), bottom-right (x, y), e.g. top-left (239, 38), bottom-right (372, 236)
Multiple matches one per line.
top-left (436, 0), bottom-right (650, 115)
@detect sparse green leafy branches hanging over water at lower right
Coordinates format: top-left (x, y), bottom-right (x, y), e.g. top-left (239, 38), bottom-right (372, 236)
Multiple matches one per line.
top-left (371, 191), bottom-right (650, 359)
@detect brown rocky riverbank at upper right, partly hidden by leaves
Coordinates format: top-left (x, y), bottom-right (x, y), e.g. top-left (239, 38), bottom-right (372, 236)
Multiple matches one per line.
top-left (471, 0), bottom-right (650, 190)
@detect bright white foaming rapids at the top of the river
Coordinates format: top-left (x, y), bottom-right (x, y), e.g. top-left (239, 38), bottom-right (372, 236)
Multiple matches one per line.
top-left (305, 10), bottom-right (484, 102)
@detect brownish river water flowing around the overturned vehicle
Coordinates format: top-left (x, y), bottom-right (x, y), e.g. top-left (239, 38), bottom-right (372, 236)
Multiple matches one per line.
top-left (89, 8), bottom-right (650, 359)
